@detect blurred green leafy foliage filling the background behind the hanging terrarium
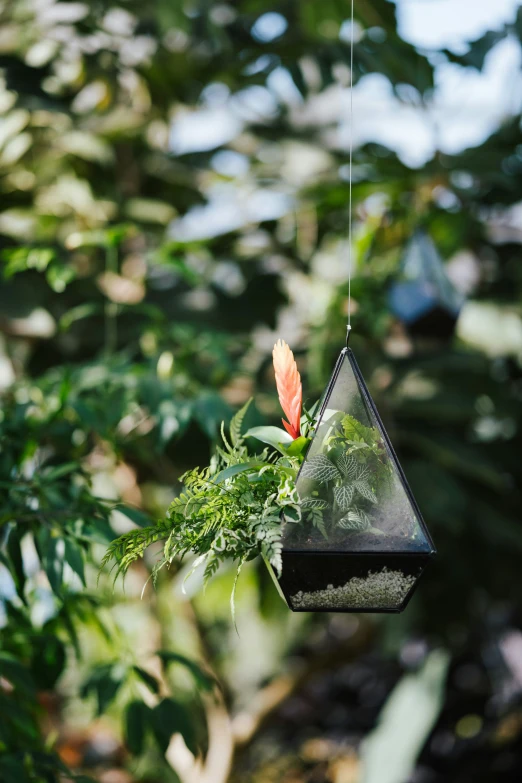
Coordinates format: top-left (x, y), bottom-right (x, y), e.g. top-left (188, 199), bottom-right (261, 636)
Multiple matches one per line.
top-left (0, 0), bottom-right (522, 783)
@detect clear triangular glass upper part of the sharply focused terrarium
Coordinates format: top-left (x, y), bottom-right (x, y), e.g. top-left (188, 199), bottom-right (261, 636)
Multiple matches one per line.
top-left (283, 349), bottom-right (433, 554)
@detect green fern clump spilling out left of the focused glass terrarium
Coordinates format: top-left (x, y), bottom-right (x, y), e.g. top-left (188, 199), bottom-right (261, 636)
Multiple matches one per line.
top-left (103, 414), bottom-right (299, 611)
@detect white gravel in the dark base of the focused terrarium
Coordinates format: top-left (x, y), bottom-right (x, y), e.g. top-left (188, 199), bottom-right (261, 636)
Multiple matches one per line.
top-left (291, 568), bottom-right (415, 611)
